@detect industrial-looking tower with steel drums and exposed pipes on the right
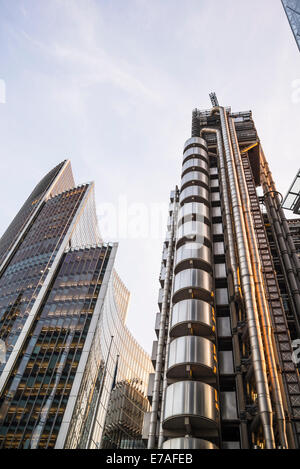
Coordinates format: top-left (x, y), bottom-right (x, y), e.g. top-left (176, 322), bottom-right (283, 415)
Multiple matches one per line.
top-left (144, 93), bottom-right (300, 449)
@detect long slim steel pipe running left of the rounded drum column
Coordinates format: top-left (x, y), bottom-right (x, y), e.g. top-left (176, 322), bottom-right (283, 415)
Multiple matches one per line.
top-left (148, 201), bottom-right (175, 449)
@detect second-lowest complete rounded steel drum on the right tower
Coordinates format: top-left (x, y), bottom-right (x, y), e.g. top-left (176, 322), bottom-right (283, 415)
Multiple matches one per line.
top-left (167, 335), bottom-right (217, 383)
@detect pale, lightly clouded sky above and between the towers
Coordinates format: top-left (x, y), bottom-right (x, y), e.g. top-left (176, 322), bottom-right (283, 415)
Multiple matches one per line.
top-left (0, 0), bottom-right (300, 353)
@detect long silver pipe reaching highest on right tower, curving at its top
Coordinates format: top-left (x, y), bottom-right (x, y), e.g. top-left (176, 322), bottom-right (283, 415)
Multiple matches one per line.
top-left (213, 107), bottom-right (275, 449)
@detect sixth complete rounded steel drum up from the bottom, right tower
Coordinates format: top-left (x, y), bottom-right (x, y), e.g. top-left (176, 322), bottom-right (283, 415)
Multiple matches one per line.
top-left (177, 220), bottom-right (211, 247)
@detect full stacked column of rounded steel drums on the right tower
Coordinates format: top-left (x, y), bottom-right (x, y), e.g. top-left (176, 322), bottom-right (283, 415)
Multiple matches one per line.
top-left (148, 133), bottom-right (219, 448)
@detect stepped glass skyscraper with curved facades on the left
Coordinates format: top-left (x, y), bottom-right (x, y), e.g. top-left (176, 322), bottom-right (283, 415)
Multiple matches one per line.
top-left (0, 161), bottom-right (152, 449)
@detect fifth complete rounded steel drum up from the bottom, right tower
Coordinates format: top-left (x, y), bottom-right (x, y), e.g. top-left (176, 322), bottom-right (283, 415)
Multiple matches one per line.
top-left (175, 242), bottom-right (212, 274)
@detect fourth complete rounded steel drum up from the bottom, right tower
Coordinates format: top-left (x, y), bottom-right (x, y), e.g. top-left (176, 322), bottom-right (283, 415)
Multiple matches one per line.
top-left (173, 269), bottom-right (213, 304)
